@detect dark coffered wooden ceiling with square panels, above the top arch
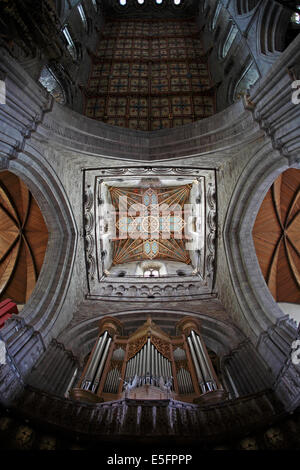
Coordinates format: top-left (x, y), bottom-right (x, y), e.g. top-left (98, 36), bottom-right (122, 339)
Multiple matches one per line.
top-left (83, 19), bottom-right (215, 131)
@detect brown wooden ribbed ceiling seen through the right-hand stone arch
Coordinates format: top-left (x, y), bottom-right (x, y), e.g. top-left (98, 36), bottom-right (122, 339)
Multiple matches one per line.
top-left (253, 169), bottom-right (300, 303)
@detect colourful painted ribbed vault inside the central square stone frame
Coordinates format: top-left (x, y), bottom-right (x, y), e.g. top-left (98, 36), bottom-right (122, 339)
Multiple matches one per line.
top-left (109, 185), bottom-right (191, 264)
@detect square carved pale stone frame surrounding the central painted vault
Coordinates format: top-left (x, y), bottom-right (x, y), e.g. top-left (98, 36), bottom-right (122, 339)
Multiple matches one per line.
top-left (83, 166), bottom-right (217, 301)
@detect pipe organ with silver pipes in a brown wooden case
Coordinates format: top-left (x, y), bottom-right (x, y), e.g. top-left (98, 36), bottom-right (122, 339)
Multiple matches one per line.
top-left (70, 317), bottom-right (227, 403)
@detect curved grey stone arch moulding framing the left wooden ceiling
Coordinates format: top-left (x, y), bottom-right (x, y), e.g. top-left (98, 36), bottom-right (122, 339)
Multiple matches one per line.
top-left (0, 149), bottom-right (78, 346)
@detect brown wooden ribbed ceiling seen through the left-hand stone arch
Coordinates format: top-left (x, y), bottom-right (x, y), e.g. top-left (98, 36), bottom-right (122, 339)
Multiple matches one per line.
top-left (0, 171), bottom-right (48, 304)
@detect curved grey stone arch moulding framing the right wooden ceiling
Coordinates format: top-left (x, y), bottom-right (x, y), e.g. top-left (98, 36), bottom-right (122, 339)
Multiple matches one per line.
top-left (223, 144), bottom-right (298, 344)
